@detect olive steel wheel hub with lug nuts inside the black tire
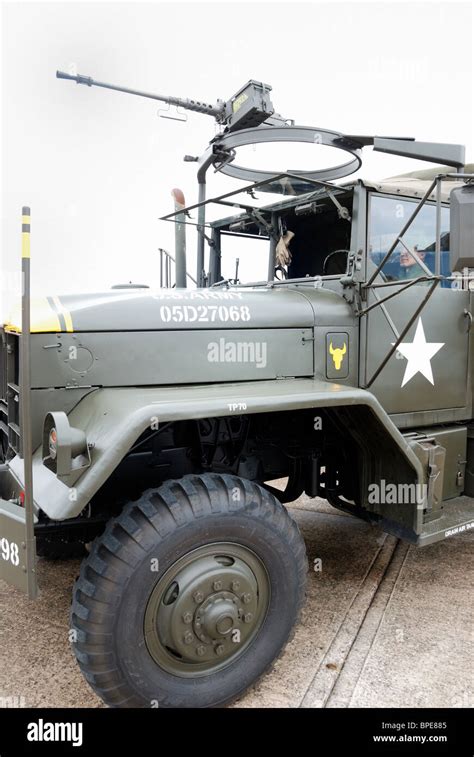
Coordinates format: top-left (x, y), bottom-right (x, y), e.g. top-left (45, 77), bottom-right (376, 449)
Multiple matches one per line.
top-left (144, 542), bottom-right (270, 676)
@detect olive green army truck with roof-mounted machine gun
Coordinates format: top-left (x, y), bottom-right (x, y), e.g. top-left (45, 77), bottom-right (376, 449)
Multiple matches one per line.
top-left (0, 74), bottom-right (474, 707)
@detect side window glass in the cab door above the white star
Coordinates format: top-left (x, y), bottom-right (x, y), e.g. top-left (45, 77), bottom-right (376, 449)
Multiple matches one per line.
top-left (368, 194), bottom-right (451, 287)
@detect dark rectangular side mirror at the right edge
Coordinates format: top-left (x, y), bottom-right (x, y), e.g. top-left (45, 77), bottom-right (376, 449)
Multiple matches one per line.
top-left (450, 184), bottom-right (474, 271)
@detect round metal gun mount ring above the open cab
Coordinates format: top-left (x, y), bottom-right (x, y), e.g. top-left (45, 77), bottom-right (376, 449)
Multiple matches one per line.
top-left (214, 124), bottom-right (362, 192)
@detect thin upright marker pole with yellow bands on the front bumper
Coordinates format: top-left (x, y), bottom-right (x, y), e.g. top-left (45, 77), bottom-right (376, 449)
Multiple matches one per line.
top-left (20, 207), bottom-right (38, 599)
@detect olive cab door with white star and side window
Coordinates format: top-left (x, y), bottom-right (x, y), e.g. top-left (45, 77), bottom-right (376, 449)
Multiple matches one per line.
top-left (361, 192), bottom-right (470, 416)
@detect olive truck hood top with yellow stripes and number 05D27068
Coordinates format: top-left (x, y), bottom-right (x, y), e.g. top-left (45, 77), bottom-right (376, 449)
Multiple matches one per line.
top-left (5, 287), bottom-right (320, 333)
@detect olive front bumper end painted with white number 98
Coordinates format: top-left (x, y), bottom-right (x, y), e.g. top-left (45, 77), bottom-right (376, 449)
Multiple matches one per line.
top-left (0, 465), bottom-right (38, 598)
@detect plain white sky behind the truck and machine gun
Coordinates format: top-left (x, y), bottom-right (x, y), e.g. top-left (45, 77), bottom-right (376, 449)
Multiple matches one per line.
top-left (0, 1), bottom-right (474, 316)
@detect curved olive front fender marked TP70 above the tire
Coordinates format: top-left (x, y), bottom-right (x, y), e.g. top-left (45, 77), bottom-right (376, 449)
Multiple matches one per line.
top-left (10, 378), bottom-right (423, 520)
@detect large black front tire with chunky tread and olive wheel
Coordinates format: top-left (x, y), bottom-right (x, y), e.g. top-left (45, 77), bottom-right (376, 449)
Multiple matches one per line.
top-left (71, 473), bottom-right (307, 707)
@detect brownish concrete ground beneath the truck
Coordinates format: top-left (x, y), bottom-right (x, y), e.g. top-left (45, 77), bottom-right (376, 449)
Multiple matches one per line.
top-left (0, 497), bottom-right (474, 707)
